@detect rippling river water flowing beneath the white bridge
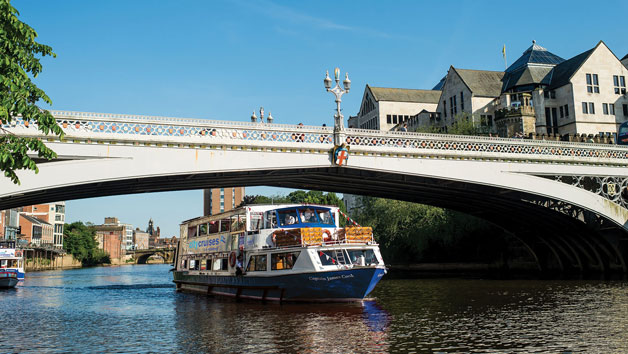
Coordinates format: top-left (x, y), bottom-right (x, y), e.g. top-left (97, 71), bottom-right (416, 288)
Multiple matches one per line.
top-left (0, 265), bottom-right (628, 353)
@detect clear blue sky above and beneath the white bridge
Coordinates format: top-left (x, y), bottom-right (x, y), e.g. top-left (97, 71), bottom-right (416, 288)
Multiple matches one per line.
top-left (12, 0), bottom-right (628, 236)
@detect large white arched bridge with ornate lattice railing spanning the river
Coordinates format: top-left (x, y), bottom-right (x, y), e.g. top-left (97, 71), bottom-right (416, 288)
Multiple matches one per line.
top-left (0, 111), bottom-right (628, 273)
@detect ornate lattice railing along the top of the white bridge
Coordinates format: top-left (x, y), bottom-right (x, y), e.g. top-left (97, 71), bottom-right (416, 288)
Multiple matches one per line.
top-left (3, 111), bottom-right (628, 165)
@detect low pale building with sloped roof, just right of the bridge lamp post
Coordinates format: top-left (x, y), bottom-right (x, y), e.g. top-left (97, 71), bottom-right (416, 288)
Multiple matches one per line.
top-left (348, 85), bottom-right (441, 130)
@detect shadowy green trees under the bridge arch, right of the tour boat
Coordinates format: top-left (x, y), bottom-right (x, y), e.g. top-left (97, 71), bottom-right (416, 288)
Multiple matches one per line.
top-left (356, 197), bottom-right (505, 263)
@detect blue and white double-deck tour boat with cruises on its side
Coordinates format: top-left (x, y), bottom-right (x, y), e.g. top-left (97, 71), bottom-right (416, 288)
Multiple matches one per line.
top-left (173, 204), bottom-right (386, 302)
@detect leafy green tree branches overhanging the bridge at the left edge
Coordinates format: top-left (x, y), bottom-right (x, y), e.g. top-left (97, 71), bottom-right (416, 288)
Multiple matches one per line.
top-left (0, 0), bottom-right (63, 184)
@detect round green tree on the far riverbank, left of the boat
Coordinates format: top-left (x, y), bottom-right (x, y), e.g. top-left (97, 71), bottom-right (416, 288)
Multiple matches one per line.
top-left (63, 221), bottom-right (111, 266)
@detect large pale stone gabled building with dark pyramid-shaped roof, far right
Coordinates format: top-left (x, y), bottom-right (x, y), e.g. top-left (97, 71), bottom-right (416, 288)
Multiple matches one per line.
top-left (438, 41), bottom-right (628, 137)
